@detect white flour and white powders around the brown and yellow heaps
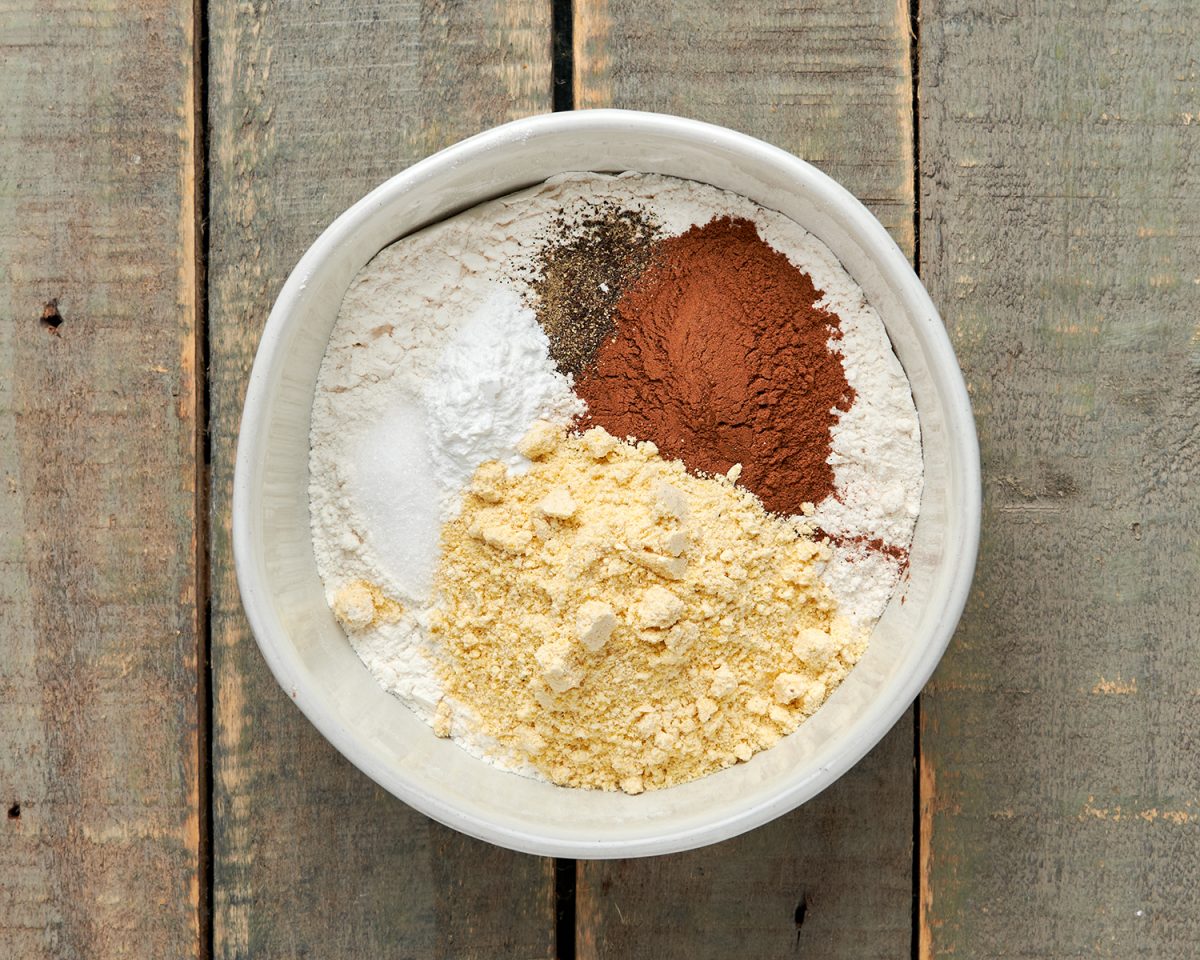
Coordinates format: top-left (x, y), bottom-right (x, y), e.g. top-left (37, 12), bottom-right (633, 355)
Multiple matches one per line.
top-left (310, 174), bottom-right (922, 744)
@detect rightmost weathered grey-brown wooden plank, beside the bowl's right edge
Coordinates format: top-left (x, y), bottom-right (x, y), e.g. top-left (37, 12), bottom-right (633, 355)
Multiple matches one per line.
top-left (919, 0), bottom-right (1200, 958)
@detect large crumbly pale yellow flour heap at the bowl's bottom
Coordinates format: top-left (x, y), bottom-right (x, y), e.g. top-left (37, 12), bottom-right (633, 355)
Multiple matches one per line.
top-left (431, 424), bottom-right (865, 793)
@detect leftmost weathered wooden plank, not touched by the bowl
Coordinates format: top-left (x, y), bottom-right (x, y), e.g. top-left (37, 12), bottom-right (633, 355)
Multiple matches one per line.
top-left (0, 0), bottom-right (202, 958)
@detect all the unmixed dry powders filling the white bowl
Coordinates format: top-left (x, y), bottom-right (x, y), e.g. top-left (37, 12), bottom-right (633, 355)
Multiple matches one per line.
top-left (311, 174), bottom-right (922, 793)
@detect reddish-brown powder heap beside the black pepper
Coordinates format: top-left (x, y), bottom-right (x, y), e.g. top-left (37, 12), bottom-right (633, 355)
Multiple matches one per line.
top-left (576, 217), bottom-right (854, 514)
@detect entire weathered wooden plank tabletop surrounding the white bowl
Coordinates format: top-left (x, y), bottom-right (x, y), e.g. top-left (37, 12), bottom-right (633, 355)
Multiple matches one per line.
top-left (0, 0), bottom-right (1200, 960)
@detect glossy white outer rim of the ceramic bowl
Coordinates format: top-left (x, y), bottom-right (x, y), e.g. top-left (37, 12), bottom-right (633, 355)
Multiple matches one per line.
top-left (232, 109), bottom-right (982, 858)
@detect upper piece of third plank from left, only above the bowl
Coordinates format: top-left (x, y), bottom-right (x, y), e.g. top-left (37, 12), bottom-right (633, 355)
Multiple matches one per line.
top-left (575, 0), bottom-right (913, 251)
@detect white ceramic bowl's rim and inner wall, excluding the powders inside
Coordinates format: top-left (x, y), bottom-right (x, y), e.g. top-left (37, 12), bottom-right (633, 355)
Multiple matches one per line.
top-left (233, 110), bottom-right (979, 858)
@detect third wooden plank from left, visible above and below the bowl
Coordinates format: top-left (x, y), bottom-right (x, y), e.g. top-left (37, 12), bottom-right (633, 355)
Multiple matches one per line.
top-left (575, 0), bottom-right (913, 960)
